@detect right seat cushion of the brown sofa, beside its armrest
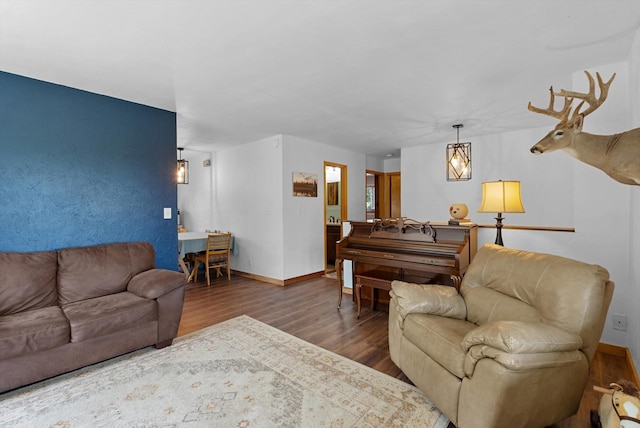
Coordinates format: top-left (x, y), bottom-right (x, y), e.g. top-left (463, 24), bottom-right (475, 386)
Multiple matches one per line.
top-left (62, 291), bottom-right (158, 342)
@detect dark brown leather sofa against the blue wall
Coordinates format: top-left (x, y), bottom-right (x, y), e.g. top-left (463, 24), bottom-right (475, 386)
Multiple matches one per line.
top-left (0, 242), bottom-right (186, 392)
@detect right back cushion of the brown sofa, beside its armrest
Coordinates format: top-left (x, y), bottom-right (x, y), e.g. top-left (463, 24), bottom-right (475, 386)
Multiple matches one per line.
top-left (58, 242), bottom-right (155, 305)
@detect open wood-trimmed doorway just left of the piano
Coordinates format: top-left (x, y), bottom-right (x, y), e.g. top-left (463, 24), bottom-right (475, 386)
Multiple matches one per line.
top-left (323, 161), bottom-right (348, 274)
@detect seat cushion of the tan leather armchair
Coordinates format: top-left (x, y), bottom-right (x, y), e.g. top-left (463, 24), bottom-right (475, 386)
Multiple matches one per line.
top-left (403, 314), bottom-right (478, 379)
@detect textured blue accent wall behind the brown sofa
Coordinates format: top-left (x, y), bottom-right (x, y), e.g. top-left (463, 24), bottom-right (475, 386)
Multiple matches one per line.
top-left (0, 72), bottom-right (178, 270)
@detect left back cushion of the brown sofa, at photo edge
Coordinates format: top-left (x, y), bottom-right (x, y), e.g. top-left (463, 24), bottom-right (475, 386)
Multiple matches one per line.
top-left (0, 251), bottom-right (58, 315)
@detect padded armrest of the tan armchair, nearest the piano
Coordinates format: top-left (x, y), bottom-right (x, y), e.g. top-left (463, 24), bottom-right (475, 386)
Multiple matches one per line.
top-left (390, 281), bottom-right (467, 320)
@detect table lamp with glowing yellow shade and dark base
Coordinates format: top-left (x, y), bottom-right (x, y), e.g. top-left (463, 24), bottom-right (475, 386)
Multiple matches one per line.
top-left (478, 180), bottom-right (524, 245)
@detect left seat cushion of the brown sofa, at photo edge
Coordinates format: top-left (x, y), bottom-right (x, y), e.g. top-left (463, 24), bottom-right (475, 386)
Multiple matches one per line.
top-left (0, 306), bottom-right (70, 359)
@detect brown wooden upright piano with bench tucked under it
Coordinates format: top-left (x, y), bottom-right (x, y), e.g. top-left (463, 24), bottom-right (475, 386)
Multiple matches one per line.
top-left (336, 218), bottom-right (478, 315)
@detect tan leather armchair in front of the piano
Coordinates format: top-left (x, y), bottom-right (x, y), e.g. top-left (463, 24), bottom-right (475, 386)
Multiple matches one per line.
top-left (389, 244), bottom-right (614, 428)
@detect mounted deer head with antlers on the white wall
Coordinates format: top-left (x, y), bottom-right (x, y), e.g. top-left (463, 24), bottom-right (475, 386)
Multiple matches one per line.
top-left (528, 71), bottom-right (640, 186)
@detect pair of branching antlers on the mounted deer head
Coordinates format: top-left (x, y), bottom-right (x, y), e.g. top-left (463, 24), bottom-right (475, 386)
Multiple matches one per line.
top-left (527, 70), bottom-right (616, 124)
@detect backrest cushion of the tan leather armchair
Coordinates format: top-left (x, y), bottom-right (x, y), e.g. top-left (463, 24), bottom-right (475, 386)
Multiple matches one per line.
top-left (460, 244), bottom-right (613, 360)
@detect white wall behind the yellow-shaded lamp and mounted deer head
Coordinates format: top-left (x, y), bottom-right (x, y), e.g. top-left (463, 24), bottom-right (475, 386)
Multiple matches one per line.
top-left (402, 64), bottom-right (640, 355)
